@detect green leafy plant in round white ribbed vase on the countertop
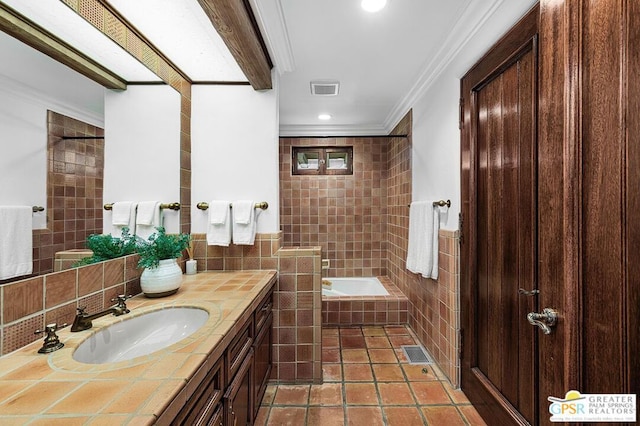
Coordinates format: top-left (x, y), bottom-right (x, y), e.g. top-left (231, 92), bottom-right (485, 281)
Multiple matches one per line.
top-left (137, 227), bottom-right (191, 297)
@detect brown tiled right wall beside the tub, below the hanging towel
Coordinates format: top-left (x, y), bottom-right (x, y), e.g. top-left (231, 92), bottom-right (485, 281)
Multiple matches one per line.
top-left (387, 114), bottom-right (460, 386)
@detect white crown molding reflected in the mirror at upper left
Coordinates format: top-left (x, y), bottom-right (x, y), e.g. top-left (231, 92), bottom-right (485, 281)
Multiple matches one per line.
top-left (0, 75), bottom-right (104, 128)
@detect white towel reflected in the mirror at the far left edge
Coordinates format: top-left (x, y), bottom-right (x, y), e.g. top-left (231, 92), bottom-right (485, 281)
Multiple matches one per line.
top-left (0, 206), bottom-right (33, 280)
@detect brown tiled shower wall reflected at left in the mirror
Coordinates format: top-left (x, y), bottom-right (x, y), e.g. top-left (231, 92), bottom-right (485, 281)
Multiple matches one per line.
top-left (28, 111), bottom-right (104, 274)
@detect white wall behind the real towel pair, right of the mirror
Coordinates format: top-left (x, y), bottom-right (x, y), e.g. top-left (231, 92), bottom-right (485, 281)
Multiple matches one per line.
top-left (191, 72), bottom-right (280, 233)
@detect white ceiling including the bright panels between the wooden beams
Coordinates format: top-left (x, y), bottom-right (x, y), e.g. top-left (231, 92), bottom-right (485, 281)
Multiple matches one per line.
top-left (0, 0), bottom-right (524, 136)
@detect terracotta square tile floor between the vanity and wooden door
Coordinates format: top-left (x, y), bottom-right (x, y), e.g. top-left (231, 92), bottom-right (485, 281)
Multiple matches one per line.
top-left (255, 325), bottom-right (485, 426)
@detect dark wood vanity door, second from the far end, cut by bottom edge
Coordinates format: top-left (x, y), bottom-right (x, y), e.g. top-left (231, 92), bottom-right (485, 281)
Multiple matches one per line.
top-left (224, 348), bottom-right (253, 426)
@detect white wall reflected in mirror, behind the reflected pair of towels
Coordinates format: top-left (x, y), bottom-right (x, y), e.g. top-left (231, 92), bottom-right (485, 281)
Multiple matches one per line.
top-left (103, 85), bottom-right (180, 233)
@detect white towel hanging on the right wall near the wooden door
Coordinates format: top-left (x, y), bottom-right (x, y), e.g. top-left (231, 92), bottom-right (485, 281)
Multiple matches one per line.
top-left (407, 201), bottom-right (440, 280)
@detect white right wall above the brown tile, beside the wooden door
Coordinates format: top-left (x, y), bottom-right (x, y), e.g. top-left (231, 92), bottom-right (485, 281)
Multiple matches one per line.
top-left (412, 0), bottom-right (535, 230)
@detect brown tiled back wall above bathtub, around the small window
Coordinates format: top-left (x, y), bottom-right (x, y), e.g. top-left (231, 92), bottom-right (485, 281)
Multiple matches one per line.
top-left (280, 138), bottom-right (389, 277)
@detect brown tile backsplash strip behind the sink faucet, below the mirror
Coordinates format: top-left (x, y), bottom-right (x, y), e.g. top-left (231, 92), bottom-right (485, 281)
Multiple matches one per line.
top-left (0, 255), bottom-right (141, 355)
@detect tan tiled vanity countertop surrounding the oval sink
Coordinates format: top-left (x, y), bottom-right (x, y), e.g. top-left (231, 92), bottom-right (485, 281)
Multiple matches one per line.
top-left (0, 271), bottom-right (276, 426)
